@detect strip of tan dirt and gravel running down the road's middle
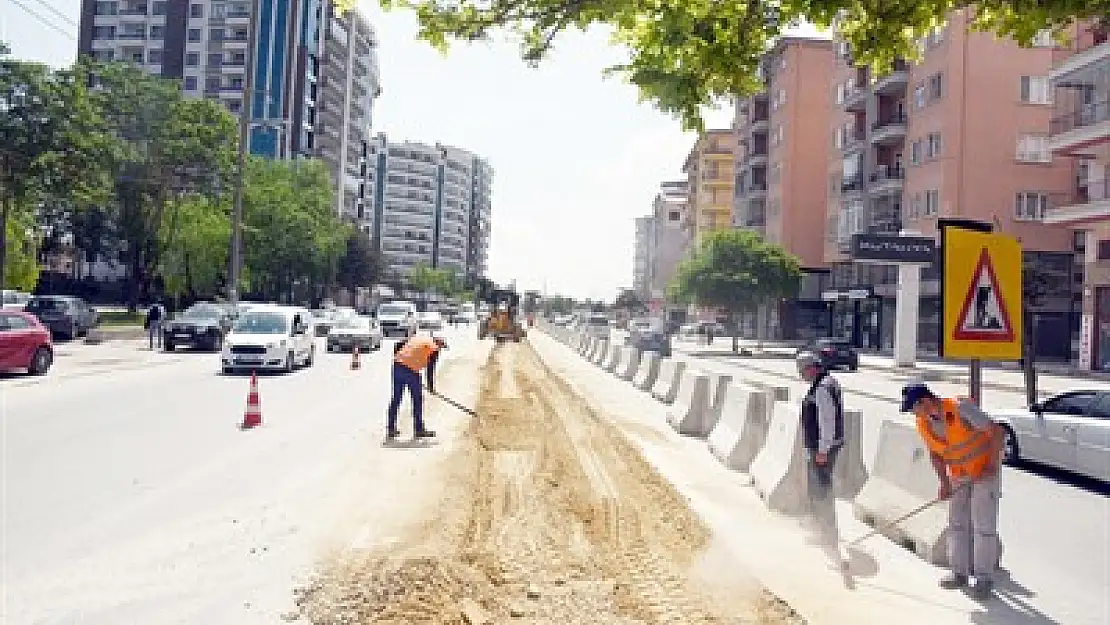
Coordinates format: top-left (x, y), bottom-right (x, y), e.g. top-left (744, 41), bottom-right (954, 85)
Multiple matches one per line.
top-left (290, 343), bottom-right (803, 625)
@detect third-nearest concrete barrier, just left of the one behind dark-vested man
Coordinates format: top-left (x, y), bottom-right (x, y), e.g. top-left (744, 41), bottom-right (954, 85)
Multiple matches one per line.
top-left (709, 383), bottom-right (775, 472)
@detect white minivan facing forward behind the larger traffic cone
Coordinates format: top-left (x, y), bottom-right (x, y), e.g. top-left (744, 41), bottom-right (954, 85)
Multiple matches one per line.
top-left (220, 305), bottom-right (316, 373)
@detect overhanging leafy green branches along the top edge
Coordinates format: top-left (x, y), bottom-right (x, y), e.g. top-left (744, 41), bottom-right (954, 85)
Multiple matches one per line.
top-left (395, 0), bottom-right (1096, 129)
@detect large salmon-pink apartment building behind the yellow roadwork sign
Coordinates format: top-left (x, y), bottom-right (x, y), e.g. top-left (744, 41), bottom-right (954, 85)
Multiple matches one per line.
top-left (821, 11), bottom-right (1073, 360)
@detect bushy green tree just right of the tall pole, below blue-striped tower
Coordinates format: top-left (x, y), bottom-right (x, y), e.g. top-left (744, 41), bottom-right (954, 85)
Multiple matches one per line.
top-left (243, 158), bottom-right (351, 301)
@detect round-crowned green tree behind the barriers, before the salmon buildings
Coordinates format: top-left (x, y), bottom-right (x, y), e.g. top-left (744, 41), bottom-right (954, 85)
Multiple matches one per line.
top-left (672, 230), bottom-right (801, 352)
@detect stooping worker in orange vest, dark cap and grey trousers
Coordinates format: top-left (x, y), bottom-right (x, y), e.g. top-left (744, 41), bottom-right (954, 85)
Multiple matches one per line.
top-left (901, 382), bottom-right (1005, 599)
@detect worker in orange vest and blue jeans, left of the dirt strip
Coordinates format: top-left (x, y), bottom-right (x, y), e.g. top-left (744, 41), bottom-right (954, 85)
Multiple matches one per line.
top-left (385, 334), bottom-right (446, 440)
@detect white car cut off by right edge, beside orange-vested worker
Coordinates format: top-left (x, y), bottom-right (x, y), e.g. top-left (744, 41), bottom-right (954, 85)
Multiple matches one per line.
top-left (988, 390), bottom-right (1110, 482)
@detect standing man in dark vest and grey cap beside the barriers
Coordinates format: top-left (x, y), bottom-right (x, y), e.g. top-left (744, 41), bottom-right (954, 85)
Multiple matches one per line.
top-left (797, 352), bottom-right (844, 563)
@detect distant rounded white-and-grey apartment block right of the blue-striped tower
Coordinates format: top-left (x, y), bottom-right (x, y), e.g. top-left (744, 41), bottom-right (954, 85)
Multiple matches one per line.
top-left (367, 134), bottom-right (493, 278)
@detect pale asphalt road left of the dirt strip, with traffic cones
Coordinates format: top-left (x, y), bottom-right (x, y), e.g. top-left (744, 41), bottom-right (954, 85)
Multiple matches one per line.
top-left (0, 330), bottom-right (474, 625)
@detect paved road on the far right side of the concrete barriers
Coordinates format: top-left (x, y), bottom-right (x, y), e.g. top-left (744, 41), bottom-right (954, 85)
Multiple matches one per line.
top-left (676, 342), bottom-right (1110, 624)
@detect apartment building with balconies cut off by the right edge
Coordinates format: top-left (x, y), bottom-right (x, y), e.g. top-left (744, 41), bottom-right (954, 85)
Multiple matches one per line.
top-left (1045, 24), bottom-right (1110, 371)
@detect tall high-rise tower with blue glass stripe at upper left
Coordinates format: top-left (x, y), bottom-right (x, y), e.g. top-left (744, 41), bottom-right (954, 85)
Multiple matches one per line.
top-left (78, 0), bottom-right (381, 222)
